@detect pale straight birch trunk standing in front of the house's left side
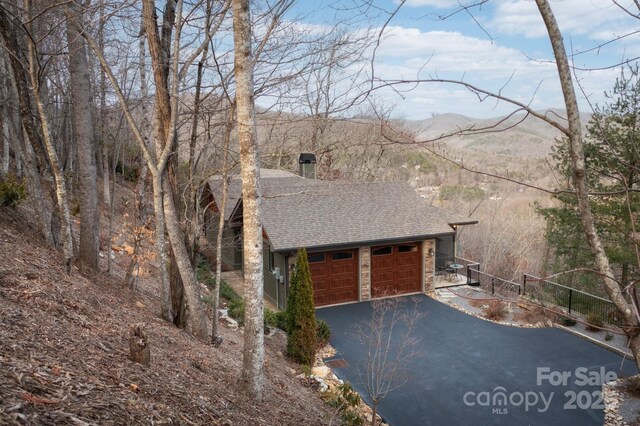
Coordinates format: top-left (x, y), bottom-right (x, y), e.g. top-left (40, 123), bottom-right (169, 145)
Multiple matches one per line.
top-left (232, 0), bottom-right (264, 401)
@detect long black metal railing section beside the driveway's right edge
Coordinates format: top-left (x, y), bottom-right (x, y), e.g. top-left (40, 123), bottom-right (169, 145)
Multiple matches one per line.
top-left (522, 274), bottom-right (624, 326)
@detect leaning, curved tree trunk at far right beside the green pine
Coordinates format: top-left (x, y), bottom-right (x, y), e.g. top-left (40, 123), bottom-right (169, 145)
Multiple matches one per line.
top-left (536, 0), bottom-right (640, 368)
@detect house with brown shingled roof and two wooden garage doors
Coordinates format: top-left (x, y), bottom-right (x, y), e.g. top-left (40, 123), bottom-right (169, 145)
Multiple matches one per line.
top-left (204, 154), bottom-right (477, 309)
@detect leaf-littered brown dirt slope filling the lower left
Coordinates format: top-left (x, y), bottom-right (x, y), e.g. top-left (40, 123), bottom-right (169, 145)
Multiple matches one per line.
top-left (0, 199), bottom-right (336, 425)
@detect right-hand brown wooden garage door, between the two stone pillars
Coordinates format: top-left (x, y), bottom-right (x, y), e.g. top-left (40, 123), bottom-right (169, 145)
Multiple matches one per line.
top-left (371, 242), bottom-right (422, 297)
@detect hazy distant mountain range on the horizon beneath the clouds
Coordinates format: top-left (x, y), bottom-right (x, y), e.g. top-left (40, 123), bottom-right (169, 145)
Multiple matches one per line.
top-left (406, 110), bottom-right (591, 158)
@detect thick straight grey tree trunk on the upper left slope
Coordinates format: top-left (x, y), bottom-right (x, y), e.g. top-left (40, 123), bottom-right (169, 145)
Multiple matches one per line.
top-left (67, 0), bottom-right (99, 273)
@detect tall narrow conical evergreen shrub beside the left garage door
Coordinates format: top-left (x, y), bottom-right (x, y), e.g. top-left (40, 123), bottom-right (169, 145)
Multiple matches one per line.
top-left (287, 249), bottom-right (318, 366)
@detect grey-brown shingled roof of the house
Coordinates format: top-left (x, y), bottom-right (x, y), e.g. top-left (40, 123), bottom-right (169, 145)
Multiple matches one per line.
top-left (206, 171), bottom-right (475, 251)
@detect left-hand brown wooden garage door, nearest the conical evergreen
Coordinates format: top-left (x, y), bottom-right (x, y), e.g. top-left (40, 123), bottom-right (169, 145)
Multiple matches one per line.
top-left (309, 250), bottom-right (358, 306)
